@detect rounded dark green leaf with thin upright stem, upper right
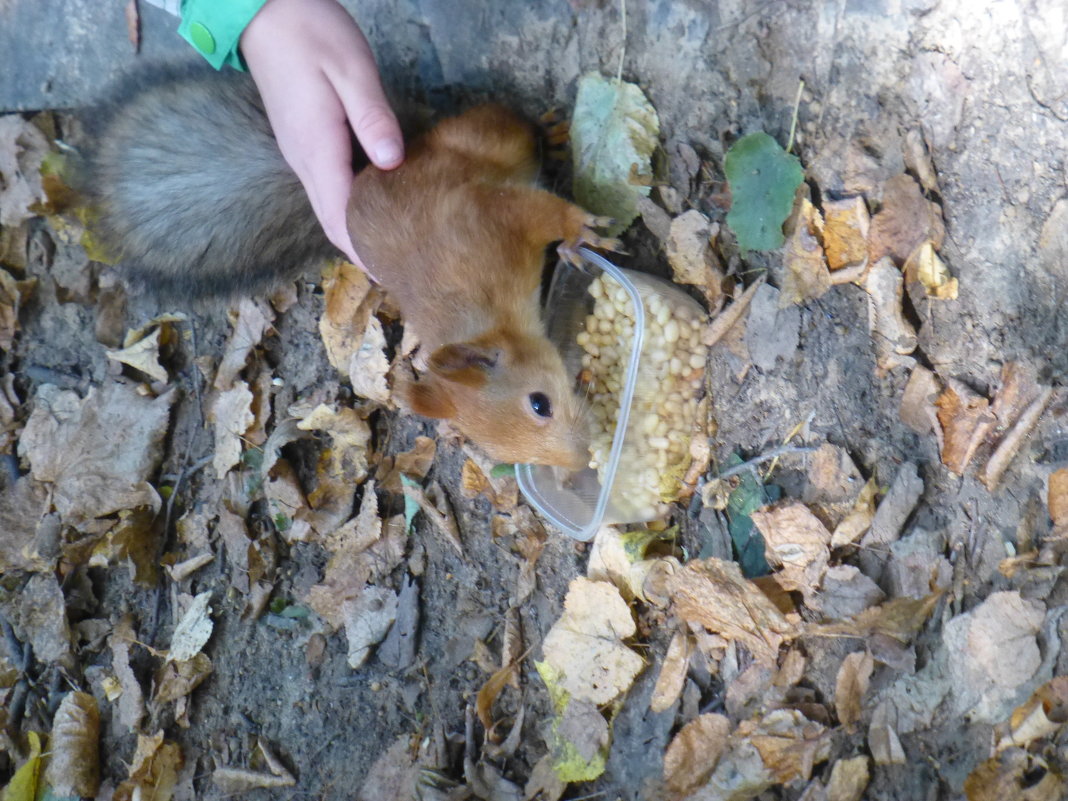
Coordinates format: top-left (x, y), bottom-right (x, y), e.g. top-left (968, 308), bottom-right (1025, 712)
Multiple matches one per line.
top-left (724, 131), bottom-right (804, 250)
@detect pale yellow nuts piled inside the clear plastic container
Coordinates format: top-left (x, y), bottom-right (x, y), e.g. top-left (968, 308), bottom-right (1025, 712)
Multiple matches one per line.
top-left (576, 274), bottom-right (708, 521)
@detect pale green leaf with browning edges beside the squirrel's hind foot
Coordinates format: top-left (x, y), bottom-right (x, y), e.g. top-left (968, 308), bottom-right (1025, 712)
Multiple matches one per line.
top-left (571, 73), bottom-right (660, 236)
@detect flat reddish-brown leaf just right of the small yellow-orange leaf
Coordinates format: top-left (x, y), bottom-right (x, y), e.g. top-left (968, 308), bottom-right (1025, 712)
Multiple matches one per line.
top-left (868, 174), bottom-right (945, 267)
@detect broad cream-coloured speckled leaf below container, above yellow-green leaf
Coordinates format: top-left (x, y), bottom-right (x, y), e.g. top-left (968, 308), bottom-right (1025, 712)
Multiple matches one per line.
top-left (541, 578), bottom-right (645, 705)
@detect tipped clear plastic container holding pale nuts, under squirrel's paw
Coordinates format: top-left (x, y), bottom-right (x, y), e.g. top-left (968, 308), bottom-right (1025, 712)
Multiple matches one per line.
top-left (516, 248), bottom-right (707, 541)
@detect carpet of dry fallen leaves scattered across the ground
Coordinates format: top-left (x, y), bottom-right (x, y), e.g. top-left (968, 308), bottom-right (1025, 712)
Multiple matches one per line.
top-left (0, 39), bottom-right (1068, 801)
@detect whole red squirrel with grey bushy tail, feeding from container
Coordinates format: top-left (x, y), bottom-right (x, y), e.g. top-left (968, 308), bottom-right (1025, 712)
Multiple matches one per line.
top-left (89, 75), bottom-right (617, 469)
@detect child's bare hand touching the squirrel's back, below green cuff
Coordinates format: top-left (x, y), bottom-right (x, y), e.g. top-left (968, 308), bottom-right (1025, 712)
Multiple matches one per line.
top-left (240, 0), bottom-right (404, 264)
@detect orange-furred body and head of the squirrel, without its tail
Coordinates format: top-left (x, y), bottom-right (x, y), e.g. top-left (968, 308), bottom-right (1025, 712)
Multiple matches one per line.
top-left (348, 106), bottom-right (600, 468)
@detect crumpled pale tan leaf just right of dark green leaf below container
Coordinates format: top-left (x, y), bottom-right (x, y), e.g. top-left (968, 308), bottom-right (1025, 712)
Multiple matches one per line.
top-left (752, 502), bottom-right (831, 608)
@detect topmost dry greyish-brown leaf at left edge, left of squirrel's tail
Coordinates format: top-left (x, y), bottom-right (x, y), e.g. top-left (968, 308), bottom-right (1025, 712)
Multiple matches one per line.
top-left (0, 114), bottom-right (51, 229)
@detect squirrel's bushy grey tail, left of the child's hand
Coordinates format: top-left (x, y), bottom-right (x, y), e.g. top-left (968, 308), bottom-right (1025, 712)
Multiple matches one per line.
top-left (83, 73), bottom-right (337, 296)
